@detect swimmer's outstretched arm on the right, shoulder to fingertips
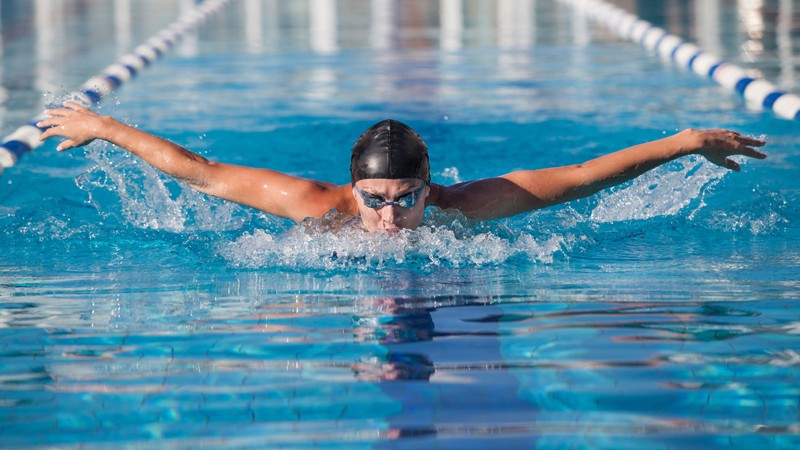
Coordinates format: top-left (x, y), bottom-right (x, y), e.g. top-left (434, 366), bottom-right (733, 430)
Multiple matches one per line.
top-left (432, 129), bottom-right (766, 219)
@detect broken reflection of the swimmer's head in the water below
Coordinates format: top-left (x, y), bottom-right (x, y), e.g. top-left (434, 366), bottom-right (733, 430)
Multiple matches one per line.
top-left (353, 298), bottom-right (436, 381)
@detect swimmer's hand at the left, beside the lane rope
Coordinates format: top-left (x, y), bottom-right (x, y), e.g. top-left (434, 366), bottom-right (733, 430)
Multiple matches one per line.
top-left (36, 102), bottom-right (113, 151)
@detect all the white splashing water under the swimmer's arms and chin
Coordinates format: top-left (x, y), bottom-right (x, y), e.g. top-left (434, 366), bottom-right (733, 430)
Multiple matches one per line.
top-left (61, 137), bottom-right (781, 271)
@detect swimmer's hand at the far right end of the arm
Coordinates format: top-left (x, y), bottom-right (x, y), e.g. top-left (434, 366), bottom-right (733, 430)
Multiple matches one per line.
top-left (677, 129), bottom-right (767, 172)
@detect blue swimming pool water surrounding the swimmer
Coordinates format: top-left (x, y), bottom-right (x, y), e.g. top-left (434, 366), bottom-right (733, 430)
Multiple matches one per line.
top-left (0, 0), bottom-right (800, 448)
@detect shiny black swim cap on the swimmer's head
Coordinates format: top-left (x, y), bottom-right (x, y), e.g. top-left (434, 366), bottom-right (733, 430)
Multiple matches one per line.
top-left (350, 120), bottom-right (431, 184)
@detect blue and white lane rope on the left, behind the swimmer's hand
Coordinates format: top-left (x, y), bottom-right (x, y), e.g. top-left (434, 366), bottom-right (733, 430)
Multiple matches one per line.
top-left (0, 0), bottom-right (231, 174)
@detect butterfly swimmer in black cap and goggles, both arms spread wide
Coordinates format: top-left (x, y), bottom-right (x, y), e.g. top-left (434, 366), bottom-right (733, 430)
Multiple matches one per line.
top-left (37, 102), bottom-right (766, 232)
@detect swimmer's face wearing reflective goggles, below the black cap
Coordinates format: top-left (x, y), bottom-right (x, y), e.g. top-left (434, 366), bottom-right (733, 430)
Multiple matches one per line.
top-left (353, 178), bottom-right (430, 232)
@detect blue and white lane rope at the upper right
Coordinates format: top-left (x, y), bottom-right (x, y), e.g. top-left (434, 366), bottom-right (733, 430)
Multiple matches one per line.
top-left (561, 0), bottom-right (800, 120)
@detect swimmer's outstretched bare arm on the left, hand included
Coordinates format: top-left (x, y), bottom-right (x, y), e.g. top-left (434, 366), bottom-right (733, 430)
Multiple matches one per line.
top-left (37, 102), bottom-right (346, 221)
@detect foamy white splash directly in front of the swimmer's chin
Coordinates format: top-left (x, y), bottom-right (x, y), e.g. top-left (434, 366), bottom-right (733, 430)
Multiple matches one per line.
top-left (219, 212), bottom-right (569, 270)
